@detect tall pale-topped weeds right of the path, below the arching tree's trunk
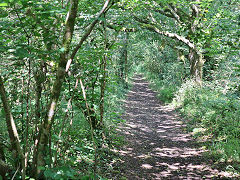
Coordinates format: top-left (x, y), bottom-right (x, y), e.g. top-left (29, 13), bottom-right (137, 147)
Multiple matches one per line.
top-left (172, 81), bottom-right (240, 171)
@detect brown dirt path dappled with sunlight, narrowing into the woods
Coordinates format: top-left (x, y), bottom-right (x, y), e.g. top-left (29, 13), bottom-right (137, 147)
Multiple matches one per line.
top-left (112, 75), bottom-right (234, 180)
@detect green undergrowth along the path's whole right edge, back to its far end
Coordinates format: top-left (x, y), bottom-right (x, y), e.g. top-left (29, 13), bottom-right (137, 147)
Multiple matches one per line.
top-left (136, 52), bottom-right (240, 173)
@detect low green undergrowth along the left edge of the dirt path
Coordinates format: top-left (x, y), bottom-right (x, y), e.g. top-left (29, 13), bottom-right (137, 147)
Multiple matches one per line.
top-left (48, 78), bottom-right (131, 180)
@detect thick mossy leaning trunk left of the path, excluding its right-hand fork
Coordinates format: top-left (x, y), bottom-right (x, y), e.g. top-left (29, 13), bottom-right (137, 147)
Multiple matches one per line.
top-left (33, 0), bottom-right (78, 178)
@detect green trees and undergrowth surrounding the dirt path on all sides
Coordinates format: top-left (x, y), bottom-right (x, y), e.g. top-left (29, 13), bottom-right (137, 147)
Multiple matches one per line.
top-left (0, 0), bottom-right (240, 179)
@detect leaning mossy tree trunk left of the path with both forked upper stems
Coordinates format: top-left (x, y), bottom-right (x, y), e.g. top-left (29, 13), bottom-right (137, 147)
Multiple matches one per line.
top-left (33, 0), bottom-right (111, 178)
